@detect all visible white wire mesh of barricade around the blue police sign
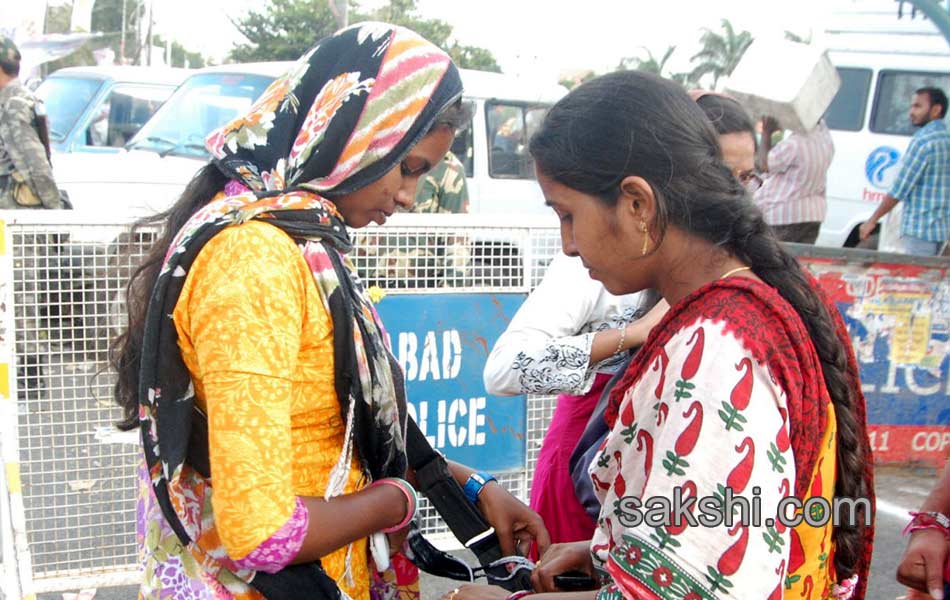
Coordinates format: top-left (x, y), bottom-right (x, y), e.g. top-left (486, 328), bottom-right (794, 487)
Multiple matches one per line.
top-left (7, 223), bottom-right (560, 591)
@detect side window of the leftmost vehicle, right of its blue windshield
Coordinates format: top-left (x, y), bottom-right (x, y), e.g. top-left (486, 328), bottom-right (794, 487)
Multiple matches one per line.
top-left (82, 85), bottom-right (175, 148)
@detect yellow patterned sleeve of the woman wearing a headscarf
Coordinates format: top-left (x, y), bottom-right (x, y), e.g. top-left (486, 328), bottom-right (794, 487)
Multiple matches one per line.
top-left (175, 222), bottom-right (320, 560)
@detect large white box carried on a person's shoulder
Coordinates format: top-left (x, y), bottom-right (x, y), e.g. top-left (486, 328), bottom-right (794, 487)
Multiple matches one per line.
top-left (725, 39), bottom-right (841, 132)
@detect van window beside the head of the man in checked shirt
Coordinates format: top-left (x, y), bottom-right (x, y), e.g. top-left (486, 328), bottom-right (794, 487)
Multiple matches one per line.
top-left (871, 71), bottom-right (950, 135)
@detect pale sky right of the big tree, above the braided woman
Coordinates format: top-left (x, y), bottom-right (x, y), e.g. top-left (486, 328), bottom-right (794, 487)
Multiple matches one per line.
top-left (410, 0), bottom-right (827, 78)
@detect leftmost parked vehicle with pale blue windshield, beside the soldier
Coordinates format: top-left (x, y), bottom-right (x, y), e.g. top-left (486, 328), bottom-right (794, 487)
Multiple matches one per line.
top-left (36, 67), bottom-right (190, 153)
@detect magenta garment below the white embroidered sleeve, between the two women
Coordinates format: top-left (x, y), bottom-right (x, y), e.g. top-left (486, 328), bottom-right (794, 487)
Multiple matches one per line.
top-left (531, 373), bottom-right (610, 544)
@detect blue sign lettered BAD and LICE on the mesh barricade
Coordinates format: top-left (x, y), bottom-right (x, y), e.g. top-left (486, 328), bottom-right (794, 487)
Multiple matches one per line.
top-left (376, 293), bottom-right (526, 472)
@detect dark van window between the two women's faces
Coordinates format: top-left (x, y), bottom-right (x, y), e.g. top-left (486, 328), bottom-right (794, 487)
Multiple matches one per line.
top-left (485, 102), bottom-right (548, 179)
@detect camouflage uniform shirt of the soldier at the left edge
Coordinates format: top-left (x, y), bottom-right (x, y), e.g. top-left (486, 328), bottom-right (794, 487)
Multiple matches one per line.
top-left (0, 84), bottom-right (62, 208)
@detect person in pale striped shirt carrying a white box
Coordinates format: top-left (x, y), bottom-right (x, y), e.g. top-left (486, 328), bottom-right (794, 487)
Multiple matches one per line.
top-left (754, 117), bottom-right (835, 244)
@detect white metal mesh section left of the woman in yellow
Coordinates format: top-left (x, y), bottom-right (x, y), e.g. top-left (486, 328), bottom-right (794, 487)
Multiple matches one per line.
top-left (10, 225), bottom-right (156, 580)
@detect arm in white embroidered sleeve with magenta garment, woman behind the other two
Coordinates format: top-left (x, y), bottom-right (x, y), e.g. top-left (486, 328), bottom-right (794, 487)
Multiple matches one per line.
top-left (484, 254), bottom-right (665, 543)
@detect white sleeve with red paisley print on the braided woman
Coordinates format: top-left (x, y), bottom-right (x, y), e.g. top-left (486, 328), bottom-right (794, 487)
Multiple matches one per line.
top-left (591, 319), bottom-right (795, 600)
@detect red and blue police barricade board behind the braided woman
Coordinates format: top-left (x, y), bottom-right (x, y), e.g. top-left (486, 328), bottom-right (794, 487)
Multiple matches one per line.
top-left (801, 257), bottom-right (950, 466)
